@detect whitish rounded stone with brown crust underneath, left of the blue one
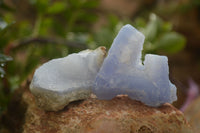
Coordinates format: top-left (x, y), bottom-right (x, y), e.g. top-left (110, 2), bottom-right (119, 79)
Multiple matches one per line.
top-left (30, 47), bottom-right (106, 111)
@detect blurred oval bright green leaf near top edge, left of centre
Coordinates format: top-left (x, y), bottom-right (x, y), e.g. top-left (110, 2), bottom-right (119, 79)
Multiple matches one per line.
top-left (47, 1), bottom-right (67, 14)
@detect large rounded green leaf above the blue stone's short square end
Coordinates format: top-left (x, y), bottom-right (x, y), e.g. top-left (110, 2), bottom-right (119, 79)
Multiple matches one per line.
top-left (155, 32), bottom-right (186, 53)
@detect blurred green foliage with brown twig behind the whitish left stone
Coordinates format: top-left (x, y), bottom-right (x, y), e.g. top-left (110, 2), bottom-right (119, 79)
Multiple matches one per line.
top-left (0, 0), bottom-right (99, 113)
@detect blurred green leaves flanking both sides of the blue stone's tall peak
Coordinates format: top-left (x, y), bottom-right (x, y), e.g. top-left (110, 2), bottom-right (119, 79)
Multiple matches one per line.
top-left (94, 13), bottom-right (186, 54)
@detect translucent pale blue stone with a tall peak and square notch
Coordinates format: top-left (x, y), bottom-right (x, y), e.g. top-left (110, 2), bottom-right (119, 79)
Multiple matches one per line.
top-left (92, 25), bottom-right (177, 107)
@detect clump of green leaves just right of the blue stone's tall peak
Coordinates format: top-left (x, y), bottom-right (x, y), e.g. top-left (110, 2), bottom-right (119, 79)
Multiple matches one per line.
top-left (136, 14), bottom-right (186, 54)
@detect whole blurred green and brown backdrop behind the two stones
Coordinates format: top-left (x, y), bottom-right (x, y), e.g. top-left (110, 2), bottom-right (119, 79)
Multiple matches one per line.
top-left (0, 0), bottom-right (200, 118)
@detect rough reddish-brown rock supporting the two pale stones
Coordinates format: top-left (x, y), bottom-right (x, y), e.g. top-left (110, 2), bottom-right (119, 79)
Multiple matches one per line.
top-left (0, 88), bottom-right (192, 133)
